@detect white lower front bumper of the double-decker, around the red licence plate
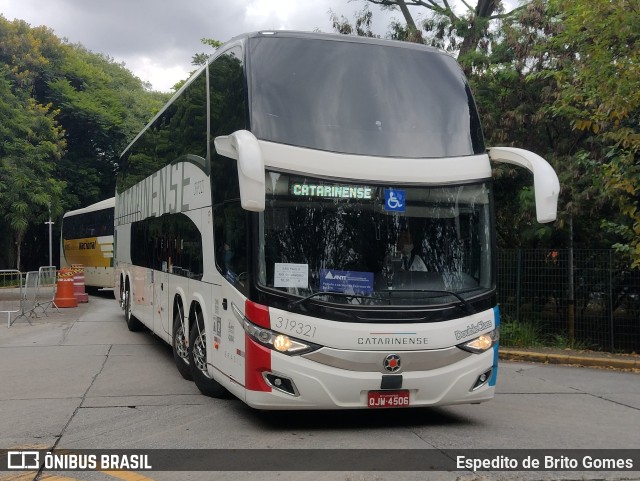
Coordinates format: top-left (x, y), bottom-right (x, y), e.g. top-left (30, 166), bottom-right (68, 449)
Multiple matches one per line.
top-left (245, 346), bottom-right (497, 409)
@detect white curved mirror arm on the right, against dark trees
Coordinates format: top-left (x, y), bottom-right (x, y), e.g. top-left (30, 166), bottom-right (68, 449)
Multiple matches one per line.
top-left (489, 147), bottom-right (560, 223)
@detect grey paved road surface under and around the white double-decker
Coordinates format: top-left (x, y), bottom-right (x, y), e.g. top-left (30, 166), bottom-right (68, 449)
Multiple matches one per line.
top-left (0, 290), bottom-right (640, 481)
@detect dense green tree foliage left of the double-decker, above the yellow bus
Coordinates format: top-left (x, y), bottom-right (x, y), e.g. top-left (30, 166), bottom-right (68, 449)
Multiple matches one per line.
top-left (0, 15), bottom-right (167, 268)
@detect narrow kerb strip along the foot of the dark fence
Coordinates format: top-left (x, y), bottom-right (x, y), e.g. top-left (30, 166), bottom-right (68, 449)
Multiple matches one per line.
top-left (500, 347), bottom-right (640, 372)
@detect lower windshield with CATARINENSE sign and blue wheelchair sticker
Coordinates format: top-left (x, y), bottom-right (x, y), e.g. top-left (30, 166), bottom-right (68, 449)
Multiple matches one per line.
top-left (258, 172), bottom-right (493, 305)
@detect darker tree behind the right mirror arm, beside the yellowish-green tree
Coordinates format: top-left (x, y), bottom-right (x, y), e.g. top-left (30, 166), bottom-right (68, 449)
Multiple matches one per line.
top-left (334, 0), bottom-right (628, 251)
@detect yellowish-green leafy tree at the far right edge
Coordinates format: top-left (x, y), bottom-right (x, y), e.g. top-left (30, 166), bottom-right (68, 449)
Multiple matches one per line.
top-left (546, 0), bottom-right (640, 268)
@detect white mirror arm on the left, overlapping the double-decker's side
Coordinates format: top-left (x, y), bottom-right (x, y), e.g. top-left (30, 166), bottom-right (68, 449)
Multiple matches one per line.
top-left (213, 130), bottom-right (265, 212)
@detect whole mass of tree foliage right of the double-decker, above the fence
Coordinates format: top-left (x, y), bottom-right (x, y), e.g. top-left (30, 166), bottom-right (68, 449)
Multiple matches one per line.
top-left (334, 0), bottom-right (640, 266)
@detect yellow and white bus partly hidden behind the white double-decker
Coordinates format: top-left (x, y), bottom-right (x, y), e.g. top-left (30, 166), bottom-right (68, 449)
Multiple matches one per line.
top-left (60, 197), bottom-right (115, 288)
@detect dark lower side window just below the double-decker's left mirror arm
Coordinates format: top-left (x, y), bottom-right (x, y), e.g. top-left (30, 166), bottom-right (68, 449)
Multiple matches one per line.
top-left (214, 201), bottom-right (249, 293)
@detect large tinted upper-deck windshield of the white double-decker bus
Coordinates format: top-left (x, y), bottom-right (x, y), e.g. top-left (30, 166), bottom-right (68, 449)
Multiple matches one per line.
top-left (249, 36), bottom-right (485, 158)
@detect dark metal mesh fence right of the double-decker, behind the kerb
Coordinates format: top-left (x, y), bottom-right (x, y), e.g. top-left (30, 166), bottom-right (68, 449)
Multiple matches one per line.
top-left (497, 249), bottom-right (640, 352)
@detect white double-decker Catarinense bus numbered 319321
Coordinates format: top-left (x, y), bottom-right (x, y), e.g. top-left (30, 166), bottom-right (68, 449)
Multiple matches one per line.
top-left (115, 32), bottom-right (559, 409)
